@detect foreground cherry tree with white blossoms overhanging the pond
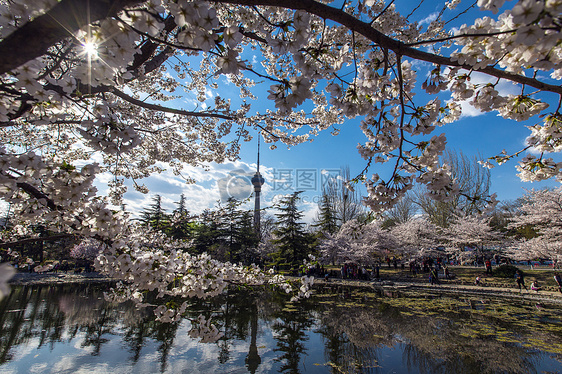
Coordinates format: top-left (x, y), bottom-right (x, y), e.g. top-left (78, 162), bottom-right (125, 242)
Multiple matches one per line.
top-left (0, 0), bottom-right (562, 310)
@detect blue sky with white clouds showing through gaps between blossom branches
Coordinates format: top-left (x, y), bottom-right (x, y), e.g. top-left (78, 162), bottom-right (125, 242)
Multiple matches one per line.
top-left (103, 1), bottom-right (559, 222)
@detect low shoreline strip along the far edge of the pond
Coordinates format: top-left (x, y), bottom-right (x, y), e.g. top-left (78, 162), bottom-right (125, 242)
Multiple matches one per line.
top-left (9, 272), bottom-right (562, 305)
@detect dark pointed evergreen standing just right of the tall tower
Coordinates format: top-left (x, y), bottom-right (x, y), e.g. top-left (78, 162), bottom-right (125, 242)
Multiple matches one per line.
top-left (273, 191), bottom-right (314, 268)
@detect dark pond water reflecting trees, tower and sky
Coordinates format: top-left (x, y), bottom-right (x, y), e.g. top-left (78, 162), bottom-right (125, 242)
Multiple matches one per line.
top-left (0, 284), bottom-right (562, 374)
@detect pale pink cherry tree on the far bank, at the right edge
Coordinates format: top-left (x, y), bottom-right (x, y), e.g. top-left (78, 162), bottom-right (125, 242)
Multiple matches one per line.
top-left (508, 187), bottom-right (562, 261)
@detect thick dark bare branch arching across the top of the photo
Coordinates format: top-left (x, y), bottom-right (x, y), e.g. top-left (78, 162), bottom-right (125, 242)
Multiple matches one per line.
top-left (0, 0), bottom-right (562, 95)
